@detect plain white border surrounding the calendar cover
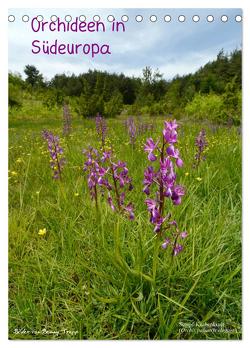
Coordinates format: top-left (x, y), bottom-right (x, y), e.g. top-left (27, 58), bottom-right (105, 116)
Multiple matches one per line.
top-left (0, 0), bottom-right (250, 348)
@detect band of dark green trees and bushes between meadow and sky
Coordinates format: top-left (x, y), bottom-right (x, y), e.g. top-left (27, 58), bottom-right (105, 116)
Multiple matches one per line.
top-left (9, 50), bottom-right (242, 125)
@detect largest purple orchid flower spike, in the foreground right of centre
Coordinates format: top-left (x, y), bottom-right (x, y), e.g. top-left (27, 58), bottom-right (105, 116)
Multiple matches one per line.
top-left (143, 120), bottom-right (187, 256)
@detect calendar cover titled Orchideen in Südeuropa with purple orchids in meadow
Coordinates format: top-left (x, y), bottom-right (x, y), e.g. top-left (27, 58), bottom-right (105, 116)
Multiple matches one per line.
top-left (8, 8), bottom-right (243, 340)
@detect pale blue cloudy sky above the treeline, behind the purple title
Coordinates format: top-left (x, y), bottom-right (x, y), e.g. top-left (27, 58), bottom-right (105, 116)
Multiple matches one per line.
top-left (9, 8), bottom-right (242, 79)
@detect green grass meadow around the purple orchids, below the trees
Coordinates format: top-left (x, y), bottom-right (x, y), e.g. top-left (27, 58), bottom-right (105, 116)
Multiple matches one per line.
top-left (9, 113), bottom-right (241, 339)
